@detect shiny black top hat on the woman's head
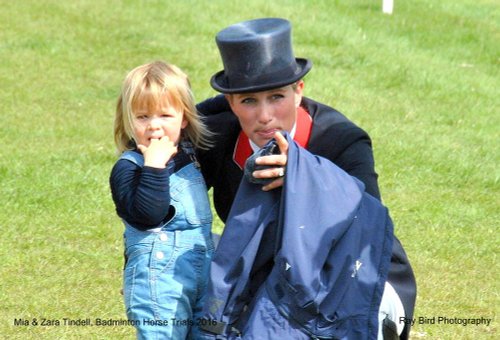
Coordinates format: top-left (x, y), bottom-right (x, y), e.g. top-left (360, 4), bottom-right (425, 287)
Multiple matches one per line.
top-left (210, 18), bottom-right (312, 93)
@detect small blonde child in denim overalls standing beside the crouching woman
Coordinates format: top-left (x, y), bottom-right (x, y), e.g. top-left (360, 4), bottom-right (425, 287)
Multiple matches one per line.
top-left (110, 61), bottom-right (213, 339)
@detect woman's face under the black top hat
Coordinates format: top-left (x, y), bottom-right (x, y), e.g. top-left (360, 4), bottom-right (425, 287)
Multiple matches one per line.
top-left (226, 80), bottom-right (304, 147)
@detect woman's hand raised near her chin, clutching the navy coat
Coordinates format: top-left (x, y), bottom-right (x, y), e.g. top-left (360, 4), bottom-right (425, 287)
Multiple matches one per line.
top-left (253, 131), bottom-right (288, 191)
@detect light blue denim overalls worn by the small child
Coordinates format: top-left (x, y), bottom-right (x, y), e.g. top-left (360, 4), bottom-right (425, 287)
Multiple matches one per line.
top-left (121, 147), bottom-right (214, 339)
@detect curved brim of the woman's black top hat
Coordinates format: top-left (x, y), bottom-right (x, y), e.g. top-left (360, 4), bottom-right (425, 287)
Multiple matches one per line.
top-left (210, 58), bottom-right (312, 94)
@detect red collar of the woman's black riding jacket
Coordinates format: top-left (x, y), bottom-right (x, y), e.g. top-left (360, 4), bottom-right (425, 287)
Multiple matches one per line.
top-left (233, 106), bottom-right (312, 169)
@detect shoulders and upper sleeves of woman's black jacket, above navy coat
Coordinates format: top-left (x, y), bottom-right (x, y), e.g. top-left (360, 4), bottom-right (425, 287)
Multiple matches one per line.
top-left (197, 97), bottom-right (380, 221)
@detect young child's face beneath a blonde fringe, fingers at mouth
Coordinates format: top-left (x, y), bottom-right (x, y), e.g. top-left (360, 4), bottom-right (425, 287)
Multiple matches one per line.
top-left (133, 95), bottom-right (188, 147)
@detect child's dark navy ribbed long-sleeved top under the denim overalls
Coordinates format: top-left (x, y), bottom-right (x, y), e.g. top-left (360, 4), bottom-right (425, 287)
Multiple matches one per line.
top-left (109, 148), bottom-right (191, 230)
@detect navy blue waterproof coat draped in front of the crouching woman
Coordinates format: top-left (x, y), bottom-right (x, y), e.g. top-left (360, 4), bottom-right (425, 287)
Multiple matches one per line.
top-left (200, 135), bottom-right (394, 339)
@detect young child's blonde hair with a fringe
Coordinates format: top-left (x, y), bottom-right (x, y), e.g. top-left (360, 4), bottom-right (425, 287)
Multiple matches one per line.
top-left (114, 61), bottom-right (210, 153)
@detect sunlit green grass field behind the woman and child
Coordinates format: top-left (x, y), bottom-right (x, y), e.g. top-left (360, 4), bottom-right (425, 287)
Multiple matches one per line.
top-left (0, 0), bottom-right (500, 339)
